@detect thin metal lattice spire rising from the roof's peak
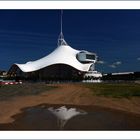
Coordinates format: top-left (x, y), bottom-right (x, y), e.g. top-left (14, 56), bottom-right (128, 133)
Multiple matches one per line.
top-left (57, 10), bottom-right (67, 46)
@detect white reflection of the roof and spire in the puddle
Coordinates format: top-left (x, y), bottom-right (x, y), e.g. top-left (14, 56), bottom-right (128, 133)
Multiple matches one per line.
top-left (48, 106), bottom-right (87, 129)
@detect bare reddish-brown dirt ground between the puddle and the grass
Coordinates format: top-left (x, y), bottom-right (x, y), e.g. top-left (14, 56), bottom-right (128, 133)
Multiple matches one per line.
top-left (0, 84), bottom-right (140, 123)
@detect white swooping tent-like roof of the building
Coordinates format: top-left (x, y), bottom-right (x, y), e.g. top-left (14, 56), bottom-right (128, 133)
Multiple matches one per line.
top-left (15, 45), bottom-right (93, 72)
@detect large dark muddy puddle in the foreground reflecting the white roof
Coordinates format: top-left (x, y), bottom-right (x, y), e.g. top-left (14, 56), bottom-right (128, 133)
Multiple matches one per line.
top-left (0, 104), bottom-right (140, 130)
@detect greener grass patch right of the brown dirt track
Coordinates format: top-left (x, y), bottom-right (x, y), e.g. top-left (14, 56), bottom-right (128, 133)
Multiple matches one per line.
top-left (84, 83), bottom-right (140, 98)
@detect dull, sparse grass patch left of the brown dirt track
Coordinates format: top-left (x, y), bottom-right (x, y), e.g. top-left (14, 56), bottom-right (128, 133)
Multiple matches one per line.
top-left (0, 83), bottom-right (56, 100)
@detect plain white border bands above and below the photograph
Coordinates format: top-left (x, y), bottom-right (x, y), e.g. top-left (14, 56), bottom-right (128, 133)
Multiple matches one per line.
top-left (0, 1), bottom-right (140, 140)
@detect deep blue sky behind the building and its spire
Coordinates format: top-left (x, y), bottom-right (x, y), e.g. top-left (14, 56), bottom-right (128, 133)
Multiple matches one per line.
top-left (0, 10), bottom-right (140, 73)
